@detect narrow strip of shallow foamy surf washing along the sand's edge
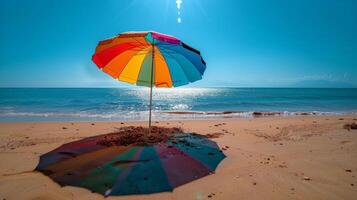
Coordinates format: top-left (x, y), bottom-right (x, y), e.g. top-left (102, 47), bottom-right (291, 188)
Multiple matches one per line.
top-left (0, 111), bottom-right (357, 123)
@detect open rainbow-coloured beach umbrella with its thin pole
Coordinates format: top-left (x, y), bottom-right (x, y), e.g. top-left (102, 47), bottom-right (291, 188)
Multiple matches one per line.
top-left (92, 31), bottom-right (206, 130)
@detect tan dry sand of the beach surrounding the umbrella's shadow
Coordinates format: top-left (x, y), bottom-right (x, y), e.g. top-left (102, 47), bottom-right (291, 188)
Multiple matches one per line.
top-left (0, 115), bottom-right (357, 200)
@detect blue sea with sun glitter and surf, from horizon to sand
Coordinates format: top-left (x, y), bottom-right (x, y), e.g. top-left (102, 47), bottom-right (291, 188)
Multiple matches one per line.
top-left (0, 87), bottom-right (357, 121)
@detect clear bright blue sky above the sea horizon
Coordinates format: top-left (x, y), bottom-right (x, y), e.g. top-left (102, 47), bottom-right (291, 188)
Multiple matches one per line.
top-left (0, 0), bottom-right (357, 87)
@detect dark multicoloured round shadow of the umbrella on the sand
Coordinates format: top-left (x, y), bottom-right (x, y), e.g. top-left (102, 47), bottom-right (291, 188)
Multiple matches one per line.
top-left (36, 127), bottom-right (226, 196)
